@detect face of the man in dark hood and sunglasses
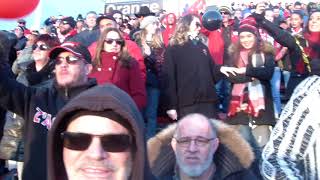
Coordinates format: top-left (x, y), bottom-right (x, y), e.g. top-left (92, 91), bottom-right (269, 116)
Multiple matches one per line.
top-left (63, 115), bottom-right (132, 180)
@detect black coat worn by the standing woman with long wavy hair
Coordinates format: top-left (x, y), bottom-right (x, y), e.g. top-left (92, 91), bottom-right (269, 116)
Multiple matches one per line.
top-left (161, 40), bottom-right (223, 110)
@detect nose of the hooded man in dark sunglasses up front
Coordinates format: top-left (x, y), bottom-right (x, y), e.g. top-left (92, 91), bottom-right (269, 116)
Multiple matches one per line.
top-left (86, 137), bottom-right (107, 160)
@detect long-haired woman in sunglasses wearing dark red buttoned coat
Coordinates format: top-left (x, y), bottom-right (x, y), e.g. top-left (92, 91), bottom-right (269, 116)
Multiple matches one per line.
top-left (90, 28), bottom-right (146, 110)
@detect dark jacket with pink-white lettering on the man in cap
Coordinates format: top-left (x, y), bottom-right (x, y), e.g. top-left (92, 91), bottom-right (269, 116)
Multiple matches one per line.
top-left (0, 63), bottom-right (96, 180)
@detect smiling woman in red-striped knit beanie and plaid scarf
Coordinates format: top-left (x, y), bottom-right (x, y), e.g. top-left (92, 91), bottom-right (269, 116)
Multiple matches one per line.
top-left (227, 18), bottom-right (275, 146)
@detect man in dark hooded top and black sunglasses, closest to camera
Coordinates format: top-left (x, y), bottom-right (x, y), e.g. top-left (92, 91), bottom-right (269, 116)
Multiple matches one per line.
top-left (48, 84), bottom-right (154, 180)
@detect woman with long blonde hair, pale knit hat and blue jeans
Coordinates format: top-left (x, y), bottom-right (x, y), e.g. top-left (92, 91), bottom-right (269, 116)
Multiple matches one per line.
top-left (136, 16), bottom-right (165, 137)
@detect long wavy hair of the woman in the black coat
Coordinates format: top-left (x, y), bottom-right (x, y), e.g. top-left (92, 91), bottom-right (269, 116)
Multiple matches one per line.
top-left (170, 14), bottom-right (198, 46)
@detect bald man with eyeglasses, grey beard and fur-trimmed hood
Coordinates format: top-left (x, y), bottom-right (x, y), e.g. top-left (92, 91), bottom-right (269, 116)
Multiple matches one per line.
top-left (148, 114), bottom-right (257, 180)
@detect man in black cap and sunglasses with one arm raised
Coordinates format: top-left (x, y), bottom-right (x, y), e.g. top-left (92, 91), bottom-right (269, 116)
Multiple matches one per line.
top-left (0, 37), bottom-right (96, 180)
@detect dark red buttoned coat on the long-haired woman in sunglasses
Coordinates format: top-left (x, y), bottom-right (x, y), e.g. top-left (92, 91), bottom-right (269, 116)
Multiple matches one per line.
top-left (89, 52), bottom-right (147, 110)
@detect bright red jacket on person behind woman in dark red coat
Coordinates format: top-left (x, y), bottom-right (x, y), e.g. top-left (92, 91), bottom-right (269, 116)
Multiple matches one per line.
top-left (88, 39), bottom-right (147, 83)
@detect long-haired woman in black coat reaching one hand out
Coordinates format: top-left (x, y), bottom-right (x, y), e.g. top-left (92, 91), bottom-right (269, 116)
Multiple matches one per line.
top-left (163, 14), bottom-right (235, 119)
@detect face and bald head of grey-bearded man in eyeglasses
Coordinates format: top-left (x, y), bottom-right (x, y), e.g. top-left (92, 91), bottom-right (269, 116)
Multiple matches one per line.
top-left (171, 117), bottom-right (219, 177)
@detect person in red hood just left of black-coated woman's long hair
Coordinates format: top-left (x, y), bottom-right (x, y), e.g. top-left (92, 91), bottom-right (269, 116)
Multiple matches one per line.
top-left (162, 13), bottom-right (177, 46)
